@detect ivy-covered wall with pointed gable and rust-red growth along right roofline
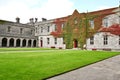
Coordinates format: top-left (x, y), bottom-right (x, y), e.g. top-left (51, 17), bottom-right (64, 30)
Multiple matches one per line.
top-left (63, 8), bottom-right (116, 49)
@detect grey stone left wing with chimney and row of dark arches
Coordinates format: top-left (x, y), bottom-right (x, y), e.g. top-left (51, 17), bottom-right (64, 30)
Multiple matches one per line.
top-left (0, 18), bottom-right (37, 47)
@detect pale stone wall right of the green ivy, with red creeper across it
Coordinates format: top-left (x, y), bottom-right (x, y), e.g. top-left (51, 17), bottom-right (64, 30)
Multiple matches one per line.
top-left (87, 9), bottom-right (120, 50)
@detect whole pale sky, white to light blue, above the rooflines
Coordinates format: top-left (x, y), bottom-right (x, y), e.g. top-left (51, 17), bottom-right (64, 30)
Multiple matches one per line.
top-left (0, 0), bottom-right (120, 23)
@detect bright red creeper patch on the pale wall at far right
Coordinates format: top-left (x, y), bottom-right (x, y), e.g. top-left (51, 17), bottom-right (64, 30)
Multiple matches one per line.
top-left (98, 24), bottom-right (120, 35)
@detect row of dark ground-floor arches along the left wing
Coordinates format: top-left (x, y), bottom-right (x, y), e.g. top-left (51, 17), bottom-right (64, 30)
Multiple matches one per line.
top-left (0, 37), bottom-right (37, 47)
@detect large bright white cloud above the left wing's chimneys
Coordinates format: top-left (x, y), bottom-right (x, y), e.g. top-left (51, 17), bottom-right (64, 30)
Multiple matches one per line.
top-left (0, 0), bottom-right (73, 23)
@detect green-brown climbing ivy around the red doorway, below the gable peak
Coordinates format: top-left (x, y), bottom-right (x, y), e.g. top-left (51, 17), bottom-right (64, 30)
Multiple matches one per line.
top-left (63, 10), bottom-right (98, 49)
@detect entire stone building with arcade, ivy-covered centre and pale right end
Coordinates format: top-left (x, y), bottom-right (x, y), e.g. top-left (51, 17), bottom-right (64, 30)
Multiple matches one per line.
top-left (0, 7), bottom-right (120, 50)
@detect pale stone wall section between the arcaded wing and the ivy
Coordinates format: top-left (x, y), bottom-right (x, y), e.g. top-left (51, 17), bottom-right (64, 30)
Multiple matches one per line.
top-left (35, 18), bottom-right (65, 48)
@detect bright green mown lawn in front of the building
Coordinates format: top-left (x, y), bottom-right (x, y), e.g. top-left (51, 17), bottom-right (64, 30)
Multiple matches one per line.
top-left (0, 48), bottom-right (118, 80)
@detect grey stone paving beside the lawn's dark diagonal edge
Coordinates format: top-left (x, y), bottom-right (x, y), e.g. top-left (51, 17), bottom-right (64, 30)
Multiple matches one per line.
top-left (47, 55), bottom-right (120, 80)
